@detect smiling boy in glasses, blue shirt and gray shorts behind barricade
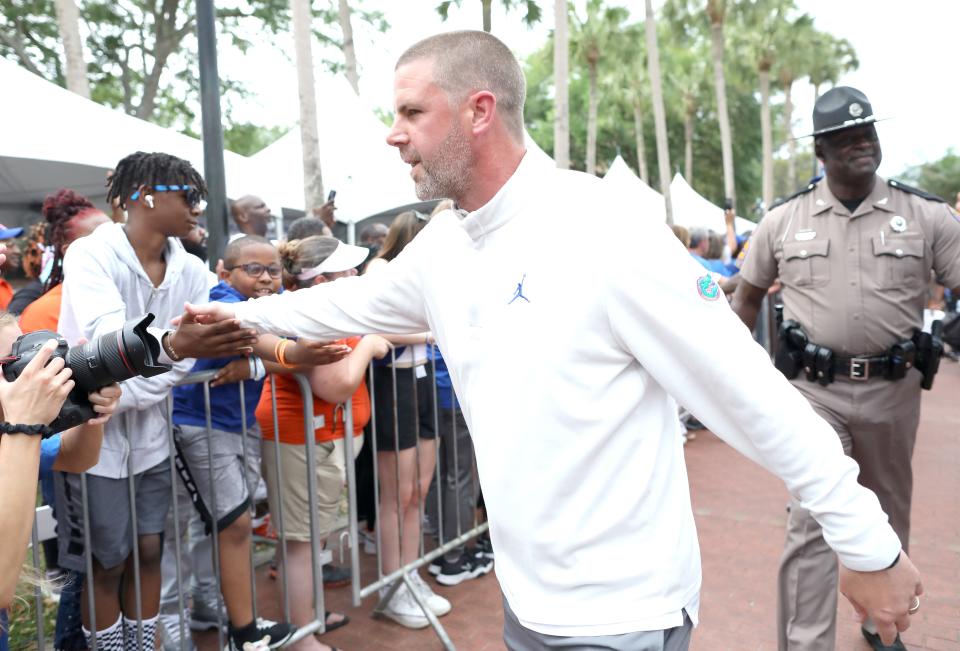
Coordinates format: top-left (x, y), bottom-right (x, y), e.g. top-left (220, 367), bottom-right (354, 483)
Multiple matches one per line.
top-left (173, 235), bottom-right (294, 649)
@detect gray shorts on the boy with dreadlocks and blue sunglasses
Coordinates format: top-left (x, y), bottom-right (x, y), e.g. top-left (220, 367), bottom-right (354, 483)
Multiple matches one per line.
top-left (55, 459), bottom-right (173, 572)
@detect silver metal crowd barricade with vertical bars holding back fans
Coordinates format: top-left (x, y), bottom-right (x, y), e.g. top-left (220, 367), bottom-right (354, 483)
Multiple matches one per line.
top-left (16, 352), bottom-right (487, 651)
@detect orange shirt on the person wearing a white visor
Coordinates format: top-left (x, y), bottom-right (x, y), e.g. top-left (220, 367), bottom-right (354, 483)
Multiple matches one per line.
top-left (256, 337), bottom-right (370, 445)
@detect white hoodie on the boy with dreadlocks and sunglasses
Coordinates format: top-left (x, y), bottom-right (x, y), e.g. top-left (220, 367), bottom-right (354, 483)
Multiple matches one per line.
top-left (58, 224), bottom-right (208, 479)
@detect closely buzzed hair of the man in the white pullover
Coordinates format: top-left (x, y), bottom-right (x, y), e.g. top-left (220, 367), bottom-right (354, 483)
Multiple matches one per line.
top-left (396, 30), bottom-right (527, 143)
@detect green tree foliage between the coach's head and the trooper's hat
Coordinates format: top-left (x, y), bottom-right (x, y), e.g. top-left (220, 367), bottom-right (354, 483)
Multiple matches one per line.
top-left (524, 0), bottom-right (857, 215)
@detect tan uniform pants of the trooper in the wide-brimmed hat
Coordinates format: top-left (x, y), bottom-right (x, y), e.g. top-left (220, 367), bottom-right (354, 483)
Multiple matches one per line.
top-left (777, 370), bottom-right (921, 651)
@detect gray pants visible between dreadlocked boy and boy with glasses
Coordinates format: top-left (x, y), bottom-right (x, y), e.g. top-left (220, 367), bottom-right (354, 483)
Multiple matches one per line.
top-left (160, 480), bottom-right (218, 615)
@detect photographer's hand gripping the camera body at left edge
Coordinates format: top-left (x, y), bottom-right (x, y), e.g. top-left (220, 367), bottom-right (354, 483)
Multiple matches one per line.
top-left (0, 339), bottom-right (74, 425)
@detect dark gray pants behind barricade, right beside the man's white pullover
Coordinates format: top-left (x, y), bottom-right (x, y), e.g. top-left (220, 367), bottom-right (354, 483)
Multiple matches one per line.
top-left (427, 407), bottom-right (477, 561)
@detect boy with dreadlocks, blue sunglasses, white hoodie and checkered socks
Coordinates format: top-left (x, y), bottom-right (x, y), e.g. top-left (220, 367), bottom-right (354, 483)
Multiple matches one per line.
top-left (57, 152), bottom-right (256, 651)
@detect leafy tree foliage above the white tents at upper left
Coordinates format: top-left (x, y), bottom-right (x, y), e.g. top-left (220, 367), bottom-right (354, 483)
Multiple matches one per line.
top-left (0, 0), bottom-right (388, 149)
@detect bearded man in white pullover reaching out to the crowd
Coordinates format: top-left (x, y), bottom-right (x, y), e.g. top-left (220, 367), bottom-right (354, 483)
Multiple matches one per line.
top-left (192, 32), bottom-right (922, 651)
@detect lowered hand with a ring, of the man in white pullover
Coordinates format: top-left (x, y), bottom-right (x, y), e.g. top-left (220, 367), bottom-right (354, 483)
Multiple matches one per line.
top-left (840, 552), bottom-right (923, 646)
